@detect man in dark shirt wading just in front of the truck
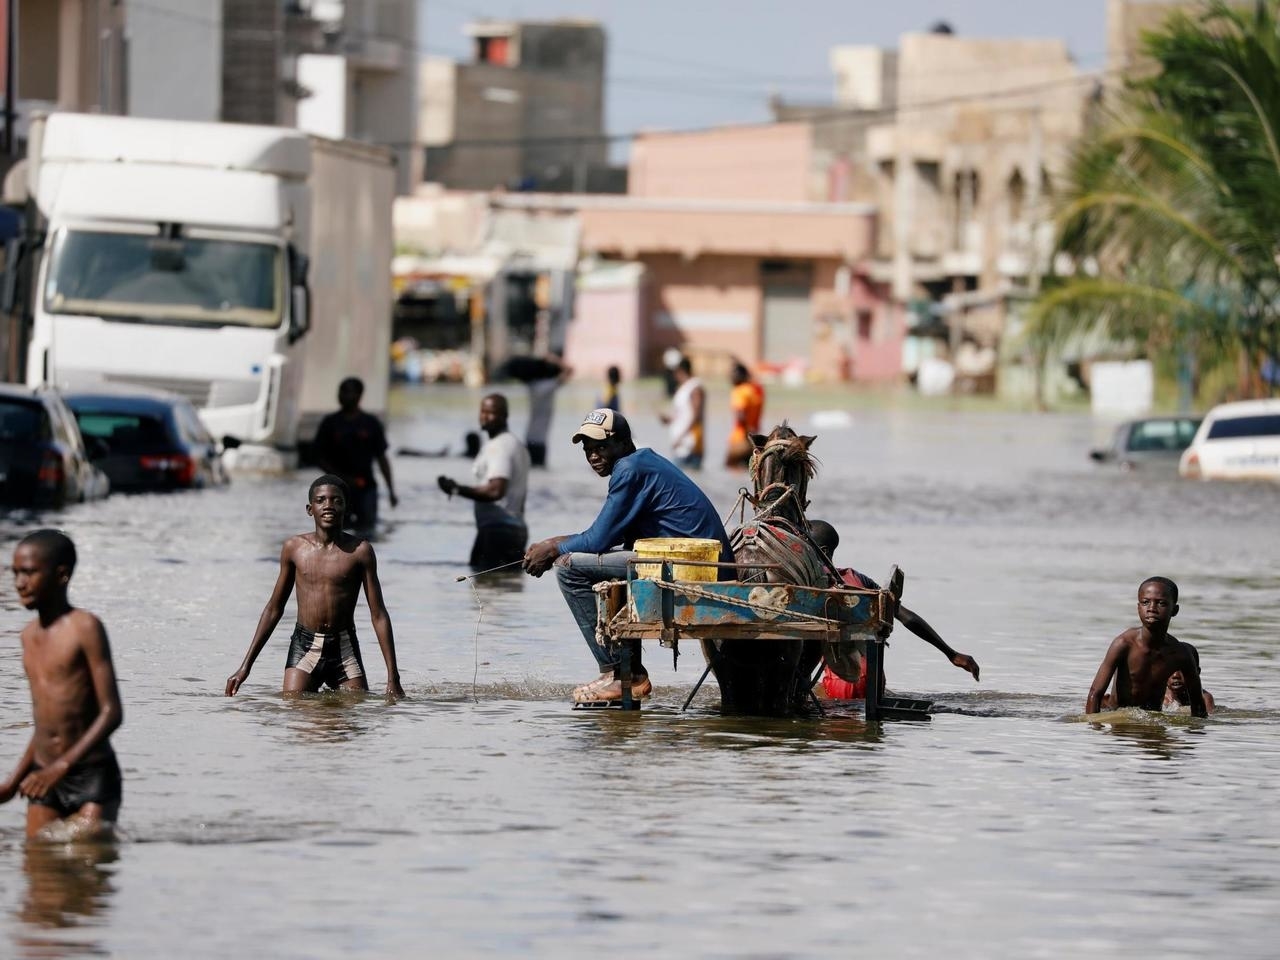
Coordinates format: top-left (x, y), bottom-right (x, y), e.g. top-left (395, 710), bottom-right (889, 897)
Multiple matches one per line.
top-left (316, 376), bottom-right (399, 530)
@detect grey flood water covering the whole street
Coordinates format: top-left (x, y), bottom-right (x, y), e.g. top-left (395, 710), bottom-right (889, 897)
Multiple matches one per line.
top-left (0, 388), bottom-right (1280, 960)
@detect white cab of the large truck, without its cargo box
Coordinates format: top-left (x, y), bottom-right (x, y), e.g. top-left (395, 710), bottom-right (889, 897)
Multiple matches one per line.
top-left (27, 114), bottom-right (310, 448)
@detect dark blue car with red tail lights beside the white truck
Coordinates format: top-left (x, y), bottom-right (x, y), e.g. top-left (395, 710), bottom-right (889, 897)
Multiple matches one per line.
top-left (67, 385), bottom-right (227, 490)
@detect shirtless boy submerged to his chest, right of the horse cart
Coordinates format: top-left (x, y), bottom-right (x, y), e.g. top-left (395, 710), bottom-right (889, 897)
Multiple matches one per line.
top-left (1084, 577), bottom-right (1208, 717)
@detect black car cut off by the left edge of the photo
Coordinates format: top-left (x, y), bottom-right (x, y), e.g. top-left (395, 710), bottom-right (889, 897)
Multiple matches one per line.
top-left (0, 384), bottom-right (110, 507)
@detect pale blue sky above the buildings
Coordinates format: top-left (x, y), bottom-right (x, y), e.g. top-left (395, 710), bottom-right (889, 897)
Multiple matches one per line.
top-left (419, 0), bottom-right (1106, 133)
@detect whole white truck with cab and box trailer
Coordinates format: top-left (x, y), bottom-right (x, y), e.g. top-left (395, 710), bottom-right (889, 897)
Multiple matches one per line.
top-left (12, 114), bottom-right (394, 467)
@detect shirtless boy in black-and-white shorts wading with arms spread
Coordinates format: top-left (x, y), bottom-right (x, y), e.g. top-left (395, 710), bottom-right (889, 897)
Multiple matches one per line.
top-left (227, 474), bottom-right (404, 696)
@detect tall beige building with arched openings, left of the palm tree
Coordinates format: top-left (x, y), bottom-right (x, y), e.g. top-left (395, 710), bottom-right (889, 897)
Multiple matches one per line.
top-left (867, 33), bottom-right (1098, 389)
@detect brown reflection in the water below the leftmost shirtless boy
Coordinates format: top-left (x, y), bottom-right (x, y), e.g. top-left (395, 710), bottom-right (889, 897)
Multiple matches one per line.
top-left (15, 842), bottom-right (119, 957)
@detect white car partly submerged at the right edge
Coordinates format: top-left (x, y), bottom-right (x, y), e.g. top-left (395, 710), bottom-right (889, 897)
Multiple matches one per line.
top-left (1178, 399), bottom-right (1280, 480)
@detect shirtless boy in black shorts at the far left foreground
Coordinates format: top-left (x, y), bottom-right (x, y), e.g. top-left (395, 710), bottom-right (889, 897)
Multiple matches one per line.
top-left (0, 530), bottom-right (124, 842)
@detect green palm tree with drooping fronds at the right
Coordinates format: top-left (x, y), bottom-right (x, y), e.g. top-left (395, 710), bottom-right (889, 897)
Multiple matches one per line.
top-left (1030, 0), bottom-right (1280, 396)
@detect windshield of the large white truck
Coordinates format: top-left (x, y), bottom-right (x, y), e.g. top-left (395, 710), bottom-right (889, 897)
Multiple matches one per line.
top-left (45, 230), bottom-right (283, 326)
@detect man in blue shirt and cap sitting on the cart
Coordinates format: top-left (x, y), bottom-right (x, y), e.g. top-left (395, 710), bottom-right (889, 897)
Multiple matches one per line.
top-left (524, 408), bottom-right (733, 703)
